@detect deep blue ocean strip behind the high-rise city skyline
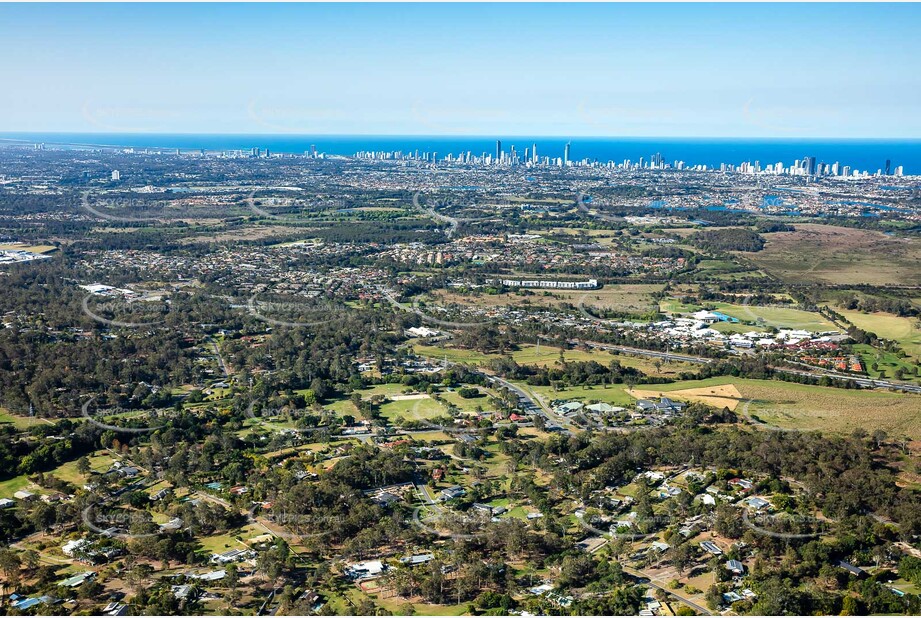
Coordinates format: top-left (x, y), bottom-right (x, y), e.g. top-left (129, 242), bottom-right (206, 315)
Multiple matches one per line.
top-left (0, 133), bottom-right (921, 174)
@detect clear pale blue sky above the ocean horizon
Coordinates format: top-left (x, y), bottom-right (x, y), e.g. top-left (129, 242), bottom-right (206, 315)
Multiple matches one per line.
top-left (0, 3), bottom-right (921, 138)
